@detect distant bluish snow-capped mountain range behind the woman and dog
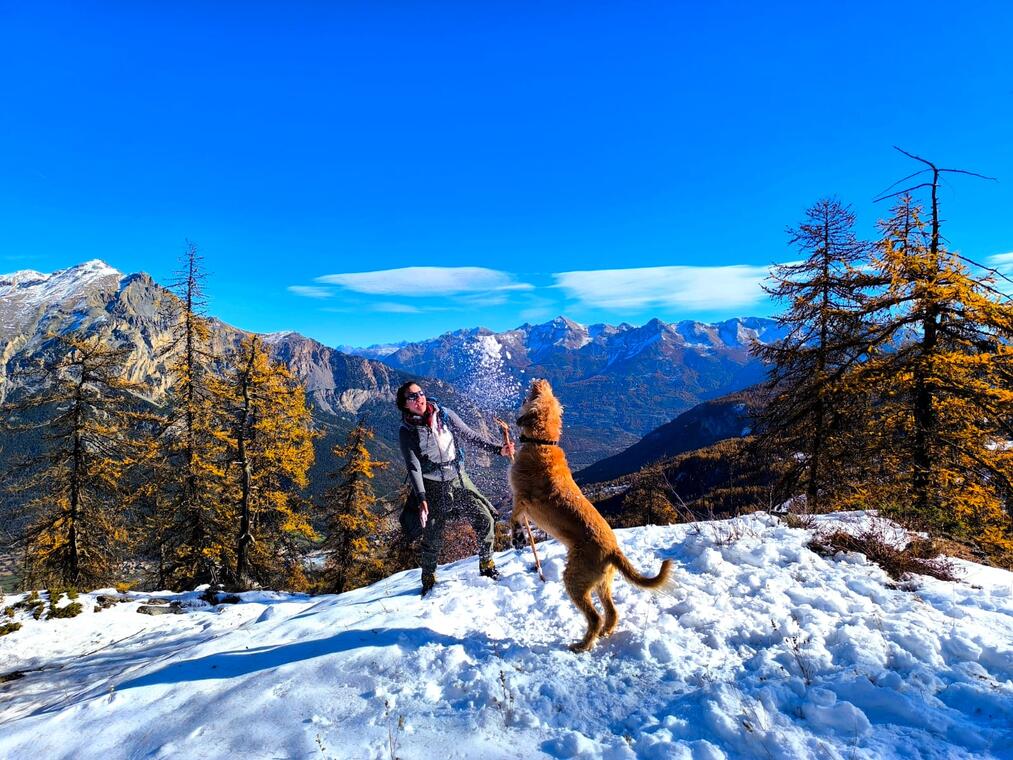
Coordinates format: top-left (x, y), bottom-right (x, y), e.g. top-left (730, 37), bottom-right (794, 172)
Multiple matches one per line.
top-left (348, 316), bottom-right (783, 468)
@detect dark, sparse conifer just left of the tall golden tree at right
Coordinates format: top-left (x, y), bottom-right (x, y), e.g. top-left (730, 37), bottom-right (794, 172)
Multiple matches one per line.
top-left (754, 199), bottom-right (873, 511)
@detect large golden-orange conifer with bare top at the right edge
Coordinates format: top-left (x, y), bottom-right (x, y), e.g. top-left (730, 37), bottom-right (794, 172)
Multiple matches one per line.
top-left (855, 177), bottom-right (1013, 556)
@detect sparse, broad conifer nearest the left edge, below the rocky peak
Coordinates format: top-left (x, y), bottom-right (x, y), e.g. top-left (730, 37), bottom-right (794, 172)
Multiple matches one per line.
top-left (7, 334), bottom-right (148, 588)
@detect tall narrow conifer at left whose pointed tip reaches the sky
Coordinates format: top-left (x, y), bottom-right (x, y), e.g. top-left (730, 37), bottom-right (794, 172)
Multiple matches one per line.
top-left (150, 243), bottom-right (236, 589)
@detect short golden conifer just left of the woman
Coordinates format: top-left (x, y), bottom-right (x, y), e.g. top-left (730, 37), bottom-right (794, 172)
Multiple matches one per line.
top-left (323, 422), bottom-right (387, 594)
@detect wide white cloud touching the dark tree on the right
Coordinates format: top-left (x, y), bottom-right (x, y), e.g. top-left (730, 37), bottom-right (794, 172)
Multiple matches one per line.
top-left (554, 264), bottom-right (770, 310)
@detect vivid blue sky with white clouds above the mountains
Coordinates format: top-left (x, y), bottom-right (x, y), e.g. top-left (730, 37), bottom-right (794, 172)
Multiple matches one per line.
top-left (0, 0), bottom-right (1013, 345)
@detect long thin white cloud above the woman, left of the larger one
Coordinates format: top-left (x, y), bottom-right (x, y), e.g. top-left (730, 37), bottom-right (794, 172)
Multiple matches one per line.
top-left (316, 267), bottom-right (534, 297)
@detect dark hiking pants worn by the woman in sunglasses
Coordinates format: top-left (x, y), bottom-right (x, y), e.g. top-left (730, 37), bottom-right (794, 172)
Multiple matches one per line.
top-left (421, 470), bottom-right (496, 573)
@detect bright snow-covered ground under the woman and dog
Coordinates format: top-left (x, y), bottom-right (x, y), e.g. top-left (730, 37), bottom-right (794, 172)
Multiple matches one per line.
top-left (0, 515), bottom-right (1013, 760)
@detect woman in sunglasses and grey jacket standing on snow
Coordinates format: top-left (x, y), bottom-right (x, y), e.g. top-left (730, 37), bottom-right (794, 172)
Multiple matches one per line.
top-left (397, 382), bottom-right (514, 596)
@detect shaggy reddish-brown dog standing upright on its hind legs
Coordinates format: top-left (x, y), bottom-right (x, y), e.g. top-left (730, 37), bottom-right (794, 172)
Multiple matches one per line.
top-left (510, 380), bottom-right (672, 652)
